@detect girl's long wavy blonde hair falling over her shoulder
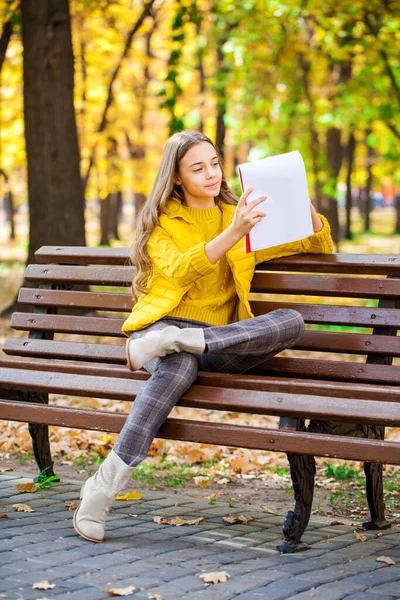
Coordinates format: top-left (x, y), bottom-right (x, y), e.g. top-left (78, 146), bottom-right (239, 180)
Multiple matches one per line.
top-left (131, 131), bottom-right (237, 301)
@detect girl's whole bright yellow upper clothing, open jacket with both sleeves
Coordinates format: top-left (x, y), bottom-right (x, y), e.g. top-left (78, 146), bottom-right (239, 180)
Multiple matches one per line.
top-left (122, 198), bottom-right (333, 336)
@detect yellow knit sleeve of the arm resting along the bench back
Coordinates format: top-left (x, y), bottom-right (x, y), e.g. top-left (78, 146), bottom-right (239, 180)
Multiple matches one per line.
top-left (255, 214), bottom-right (333, 264)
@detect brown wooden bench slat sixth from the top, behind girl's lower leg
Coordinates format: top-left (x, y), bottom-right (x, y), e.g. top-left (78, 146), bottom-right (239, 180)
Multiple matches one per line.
top-left (0, 356), bottom-right (400, 402)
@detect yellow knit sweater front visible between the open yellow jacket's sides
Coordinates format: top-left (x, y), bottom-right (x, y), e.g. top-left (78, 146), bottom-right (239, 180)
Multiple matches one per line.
top-left (169, 206), bottom-right (237, 325)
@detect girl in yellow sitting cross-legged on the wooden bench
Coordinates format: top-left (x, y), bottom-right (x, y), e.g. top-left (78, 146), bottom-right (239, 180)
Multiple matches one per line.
top-left (74, 131), bottom-right (333, 542)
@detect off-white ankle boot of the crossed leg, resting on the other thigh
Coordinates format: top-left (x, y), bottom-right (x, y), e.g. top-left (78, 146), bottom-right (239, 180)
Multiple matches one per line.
top-left (126, 325), bottom-right (206, 371)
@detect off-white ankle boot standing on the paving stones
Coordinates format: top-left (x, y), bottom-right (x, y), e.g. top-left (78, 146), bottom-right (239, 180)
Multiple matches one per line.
top-left (73, 450), bottom-right (133, 542)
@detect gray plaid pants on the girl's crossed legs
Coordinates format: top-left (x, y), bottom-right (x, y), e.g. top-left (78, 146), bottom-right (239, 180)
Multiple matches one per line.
top-left (114, 308), bottom-right (304, 467)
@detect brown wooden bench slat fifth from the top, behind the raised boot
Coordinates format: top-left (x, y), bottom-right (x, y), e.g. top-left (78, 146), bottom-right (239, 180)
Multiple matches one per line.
top-left (3, 338), bottom-right (400, 385)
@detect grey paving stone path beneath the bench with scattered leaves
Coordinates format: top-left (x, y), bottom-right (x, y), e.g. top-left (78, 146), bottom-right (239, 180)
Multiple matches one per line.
top-left (0, 472), bottom-right (400, 600)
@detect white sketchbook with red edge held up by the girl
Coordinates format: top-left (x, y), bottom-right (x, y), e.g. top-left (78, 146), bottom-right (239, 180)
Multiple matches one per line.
top-left (238, 150), bottom-right (313, 252)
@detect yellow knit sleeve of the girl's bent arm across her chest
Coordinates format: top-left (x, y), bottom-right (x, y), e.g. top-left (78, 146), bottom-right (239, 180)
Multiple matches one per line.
top-left (147, 225), bottom-right (218, 287)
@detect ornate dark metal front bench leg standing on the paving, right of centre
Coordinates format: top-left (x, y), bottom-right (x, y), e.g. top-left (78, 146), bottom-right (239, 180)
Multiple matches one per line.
top-left (277, 419), bottom-right (315, 554)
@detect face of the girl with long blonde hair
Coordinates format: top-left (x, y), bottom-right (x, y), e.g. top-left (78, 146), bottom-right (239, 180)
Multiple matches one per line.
top-left (176, 142), bottom-right (222, 208)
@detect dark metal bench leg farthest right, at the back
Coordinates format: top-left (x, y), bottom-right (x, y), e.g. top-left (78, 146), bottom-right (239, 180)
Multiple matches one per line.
top-left (363, 426), bottom-right (390, 529)
